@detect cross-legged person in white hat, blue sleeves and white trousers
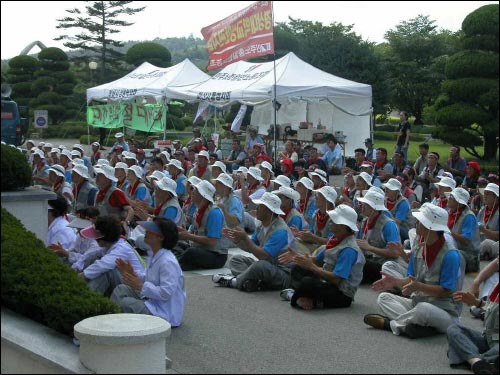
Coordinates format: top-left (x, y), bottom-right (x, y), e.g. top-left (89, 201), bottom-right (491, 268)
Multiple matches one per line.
top-left (364, 205), bottom-right (465, 338)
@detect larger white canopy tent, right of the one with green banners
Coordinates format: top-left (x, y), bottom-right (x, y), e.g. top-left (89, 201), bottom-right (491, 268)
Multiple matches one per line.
top-left (166, 52), bottom-right (372, 154)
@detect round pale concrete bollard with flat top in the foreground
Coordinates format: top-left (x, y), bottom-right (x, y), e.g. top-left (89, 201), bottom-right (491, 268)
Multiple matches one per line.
top-left (74, 314), bottom-right (170, 374)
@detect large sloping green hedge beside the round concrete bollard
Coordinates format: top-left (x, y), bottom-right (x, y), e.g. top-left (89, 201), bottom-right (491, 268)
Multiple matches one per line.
top-left (1, 208), bottom-right (119, 336)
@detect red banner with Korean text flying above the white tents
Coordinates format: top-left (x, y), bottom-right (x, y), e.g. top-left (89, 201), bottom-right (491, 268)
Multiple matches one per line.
top-left (201, 1), bottom-right (274, 70)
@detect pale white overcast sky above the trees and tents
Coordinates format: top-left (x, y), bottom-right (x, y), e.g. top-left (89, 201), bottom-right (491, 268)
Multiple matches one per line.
top-left (1, 1), bottom-right (498, 59)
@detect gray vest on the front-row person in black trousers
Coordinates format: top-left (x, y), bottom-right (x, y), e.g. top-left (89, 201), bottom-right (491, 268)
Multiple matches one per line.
top-left (323, 235), bottom-right (365, 299)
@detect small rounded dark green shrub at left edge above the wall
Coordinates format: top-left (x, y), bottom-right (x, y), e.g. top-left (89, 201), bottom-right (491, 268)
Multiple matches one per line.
top-left (2, 145), bottom-right (32, 191)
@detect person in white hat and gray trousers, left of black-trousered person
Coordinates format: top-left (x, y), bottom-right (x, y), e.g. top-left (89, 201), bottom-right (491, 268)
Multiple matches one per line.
top-left (212, 193), bottom-right (294, 292)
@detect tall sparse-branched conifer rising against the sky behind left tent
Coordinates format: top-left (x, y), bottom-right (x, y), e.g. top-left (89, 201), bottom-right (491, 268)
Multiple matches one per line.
top-left (55, 1), bottom-right (145, 82)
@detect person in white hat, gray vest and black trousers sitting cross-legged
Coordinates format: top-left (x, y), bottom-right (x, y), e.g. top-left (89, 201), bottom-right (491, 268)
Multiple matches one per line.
top-left (279, 204), bottom-right (365, 310)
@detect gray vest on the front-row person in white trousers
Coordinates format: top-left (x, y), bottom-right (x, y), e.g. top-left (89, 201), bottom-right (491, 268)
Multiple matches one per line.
top-left (411, 242), bottom-right (465, 316)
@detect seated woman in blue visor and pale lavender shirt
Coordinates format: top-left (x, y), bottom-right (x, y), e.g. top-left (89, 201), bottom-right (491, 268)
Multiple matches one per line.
top-left (111, 218), bottom-right (186, 327)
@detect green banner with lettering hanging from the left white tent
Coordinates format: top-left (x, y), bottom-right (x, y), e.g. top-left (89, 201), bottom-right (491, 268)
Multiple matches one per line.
top-left (87, 102), bottom-right (167, 132)
